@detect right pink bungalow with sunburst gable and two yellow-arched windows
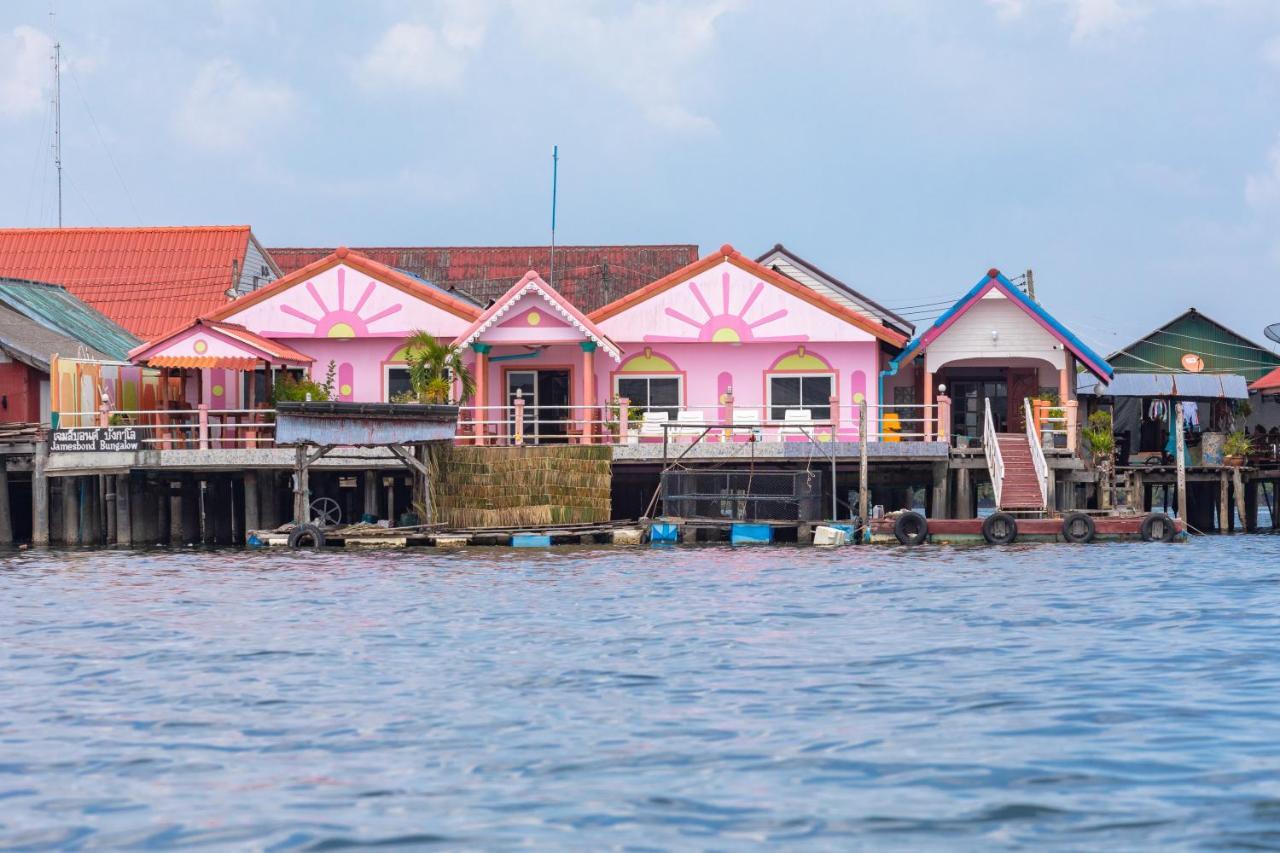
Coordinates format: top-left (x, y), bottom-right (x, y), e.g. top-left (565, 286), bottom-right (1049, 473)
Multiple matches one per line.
top-left (590, 245), bottom-right (906, 438)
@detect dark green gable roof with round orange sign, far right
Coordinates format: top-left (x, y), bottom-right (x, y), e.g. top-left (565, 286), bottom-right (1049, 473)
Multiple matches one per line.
top-left (1107, 309), bottom-right (1280, 382)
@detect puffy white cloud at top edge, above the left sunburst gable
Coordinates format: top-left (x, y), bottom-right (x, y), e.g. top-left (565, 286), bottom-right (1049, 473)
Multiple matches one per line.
top-left (353, 1), bottom-right (489, 90)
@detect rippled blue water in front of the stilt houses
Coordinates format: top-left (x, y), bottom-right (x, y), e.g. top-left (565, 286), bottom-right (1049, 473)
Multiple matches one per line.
top-left (0, 537), bottom-right (1280, 849)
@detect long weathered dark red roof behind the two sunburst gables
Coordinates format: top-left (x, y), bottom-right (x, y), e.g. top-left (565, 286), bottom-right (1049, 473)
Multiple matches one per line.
top-left (266, 245), bottom-right (698, 314)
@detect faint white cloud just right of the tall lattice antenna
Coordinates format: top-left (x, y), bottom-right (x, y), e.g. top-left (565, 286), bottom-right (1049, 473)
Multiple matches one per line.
top-left (173, 59), bottom-right (296, 152)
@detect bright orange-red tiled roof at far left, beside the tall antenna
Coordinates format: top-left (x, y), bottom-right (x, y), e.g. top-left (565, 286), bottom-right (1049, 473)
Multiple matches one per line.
top-left (0, 225), bottom-right (250, 341)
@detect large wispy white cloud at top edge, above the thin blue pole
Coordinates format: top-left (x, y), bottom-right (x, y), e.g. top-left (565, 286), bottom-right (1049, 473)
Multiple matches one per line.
top-left (513, 0), bottom-right (737, 131)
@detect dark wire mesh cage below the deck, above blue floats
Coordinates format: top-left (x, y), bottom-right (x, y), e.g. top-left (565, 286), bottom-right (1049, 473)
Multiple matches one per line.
top-left (662, 470), bottom-right (823, 521)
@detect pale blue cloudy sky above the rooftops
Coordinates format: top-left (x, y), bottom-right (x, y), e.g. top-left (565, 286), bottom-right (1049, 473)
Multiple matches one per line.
top-left (0, 0), bottom-right (1280, 352)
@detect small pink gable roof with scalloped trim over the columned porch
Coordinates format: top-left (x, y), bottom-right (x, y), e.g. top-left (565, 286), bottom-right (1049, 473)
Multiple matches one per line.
top-left (453, 270), bottom-right (622, 361)
